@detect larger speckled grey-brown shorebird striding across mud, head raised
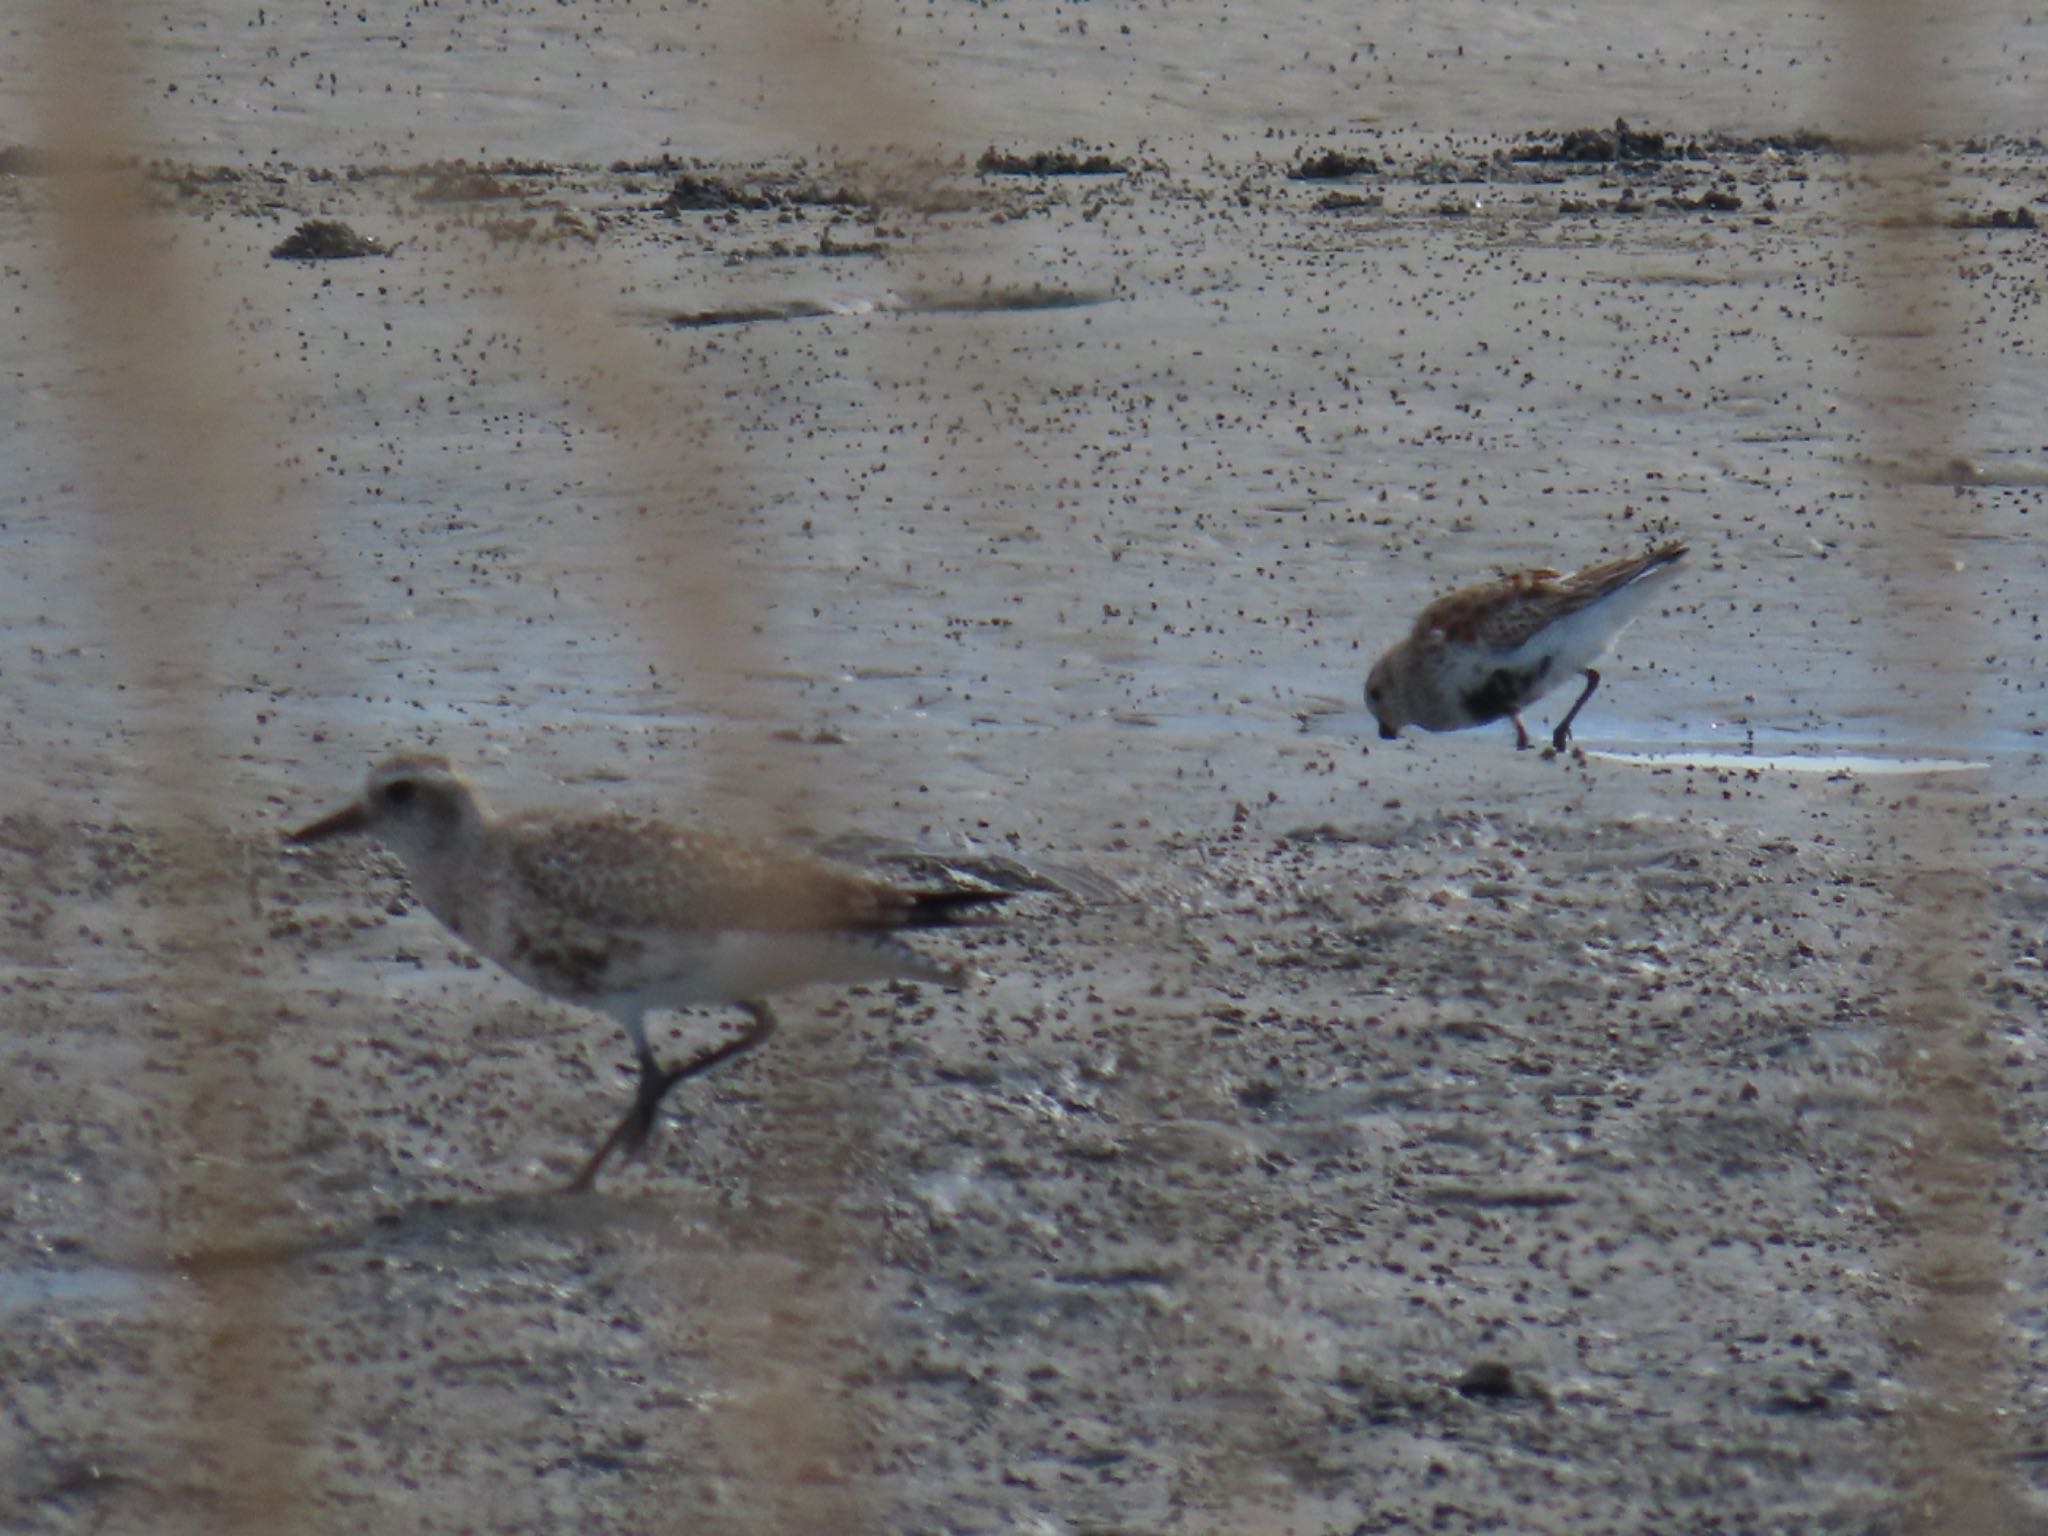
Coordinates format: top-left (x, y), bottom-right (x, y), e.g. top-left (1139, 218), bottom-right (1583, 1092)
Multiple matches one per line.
top-left (291, 754), bottom-right (1010, 1190)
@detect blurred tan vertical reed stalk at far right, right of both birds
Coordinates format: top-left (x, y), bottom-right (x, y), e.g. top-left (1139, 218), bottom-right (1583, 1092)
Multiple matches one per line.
top-left (1837, 0), bottom-right (2028, 1536)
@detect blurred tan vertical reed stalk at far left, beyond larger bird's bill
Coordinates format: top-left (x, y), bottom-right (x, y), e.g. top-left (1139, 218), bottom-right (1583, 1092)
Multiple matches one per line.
top-left (41, 0), bottom-right (307, 1532)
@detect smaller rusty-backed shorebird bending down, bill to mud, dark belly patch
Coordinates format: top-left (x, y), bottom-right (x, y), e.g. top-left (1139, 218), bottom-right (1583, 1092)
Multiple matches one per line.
top-left (1366, 543), bottom-right (1686, 752)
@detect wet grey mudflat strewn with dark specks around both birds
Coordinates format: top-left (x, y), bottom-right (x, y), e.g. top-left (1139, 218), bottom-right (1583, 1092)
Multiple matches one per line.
top-left (0, 4), bottom-right (2048, 1536)
